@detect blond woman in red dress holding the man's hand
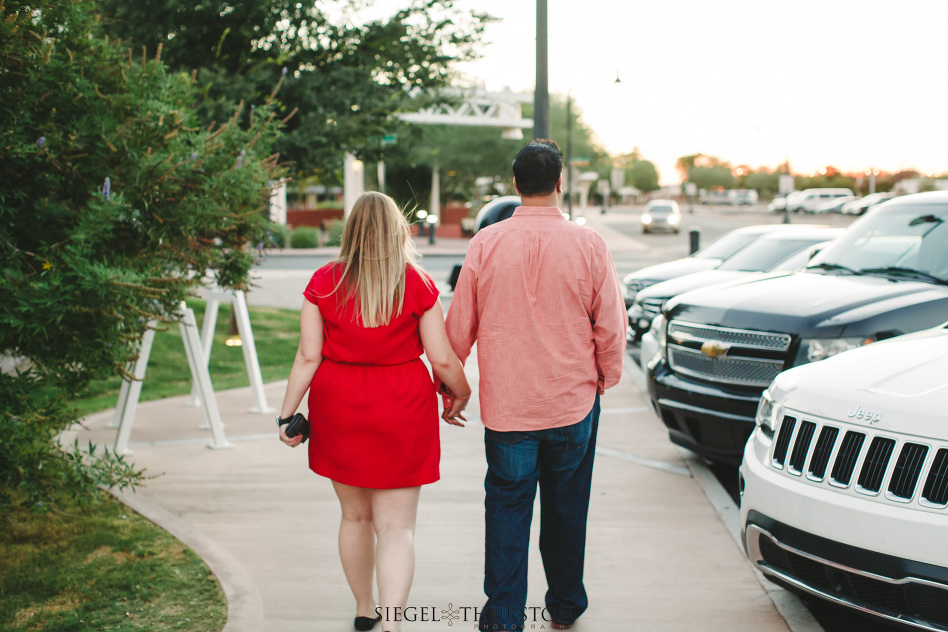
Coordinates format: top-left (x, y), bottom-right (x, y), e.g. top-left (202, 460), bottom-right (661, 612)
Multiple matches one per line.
top-left (280, 192), bottom-right (471, 632)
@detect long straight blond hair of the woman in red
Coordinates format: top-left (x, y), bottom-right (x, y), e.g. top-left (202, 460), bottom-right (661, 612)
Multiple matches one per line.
top-left (333, 191), bottom-right (430, 327)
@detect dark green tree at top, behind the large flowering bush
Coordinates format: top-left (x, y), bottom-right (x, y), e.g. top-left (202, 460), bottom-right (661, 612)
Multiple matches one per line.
top-left (101, 0), bottom-right (490, 173)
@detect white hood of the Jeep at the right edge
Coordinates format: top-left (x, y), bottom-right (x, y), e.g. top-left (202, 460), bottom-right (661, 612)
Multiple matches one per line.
top-left (770, 326), bottom-right (948, 439)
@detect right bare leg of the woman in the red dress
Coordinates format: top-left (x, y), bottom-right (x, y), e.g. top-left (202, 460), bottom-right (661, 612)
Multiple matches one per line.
top-left (372, 487), bottom-right (421, 632)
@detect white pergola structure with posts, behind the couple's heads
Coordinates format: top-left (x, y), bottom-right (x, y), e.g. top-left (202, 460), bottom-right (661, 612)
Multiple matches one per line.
top-left (344, 88), bottom-right (533, 216)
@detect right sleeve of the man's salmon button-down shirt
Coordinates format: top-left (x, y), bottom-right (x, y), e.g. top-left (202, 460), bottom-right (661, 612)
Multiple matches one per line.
top-left (592, 242), bottom-right (629, 395)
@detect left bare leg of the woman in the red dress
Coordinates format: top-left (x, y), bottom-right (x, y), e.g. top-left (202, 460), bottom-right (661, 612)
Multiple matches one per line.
top-left (332, 481), bottom-right (376, 618)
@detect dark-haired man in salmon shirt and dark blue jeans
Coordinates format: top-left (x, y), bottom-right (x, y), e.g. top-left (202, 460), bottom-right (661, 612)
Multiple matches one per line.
top-left (447, 140), bottom-right (628, 630)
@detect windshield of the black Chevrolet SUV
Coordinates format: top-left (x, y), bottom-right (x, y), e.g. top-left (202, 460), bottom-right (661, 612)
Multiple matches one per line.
top-left (808, 204), bottom-right (948, 280)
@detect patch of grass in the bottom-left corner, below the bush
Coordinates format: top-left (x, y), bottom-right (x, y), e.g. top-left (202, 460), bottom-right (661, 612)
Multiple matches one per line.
top-left (0, 493), bottom-right (227, 632)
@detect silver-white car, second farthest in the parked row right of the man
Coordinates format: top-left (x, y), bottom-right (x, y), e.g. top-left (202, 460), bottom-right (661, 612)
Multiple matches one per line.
top-left (629, 224), bottom-right (843, 342)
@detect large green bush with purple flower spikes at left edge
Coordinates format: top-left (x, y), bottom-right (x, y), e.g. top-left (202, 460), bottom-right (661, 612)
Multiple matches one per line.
top-left (0, 0), bottom-right (280, 514)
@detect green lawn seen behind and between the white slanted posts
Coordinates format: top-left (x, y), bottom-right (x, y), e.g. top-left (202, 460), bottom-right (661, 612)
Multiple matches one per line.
top-left (75, 301), bottom-right (300, 415)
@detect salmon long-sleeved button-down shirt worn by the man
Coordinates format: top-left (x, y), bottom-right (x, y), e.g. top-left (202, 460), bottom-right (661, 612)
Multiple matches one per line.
top-left (447, 206), bottom-right (628, 431)
